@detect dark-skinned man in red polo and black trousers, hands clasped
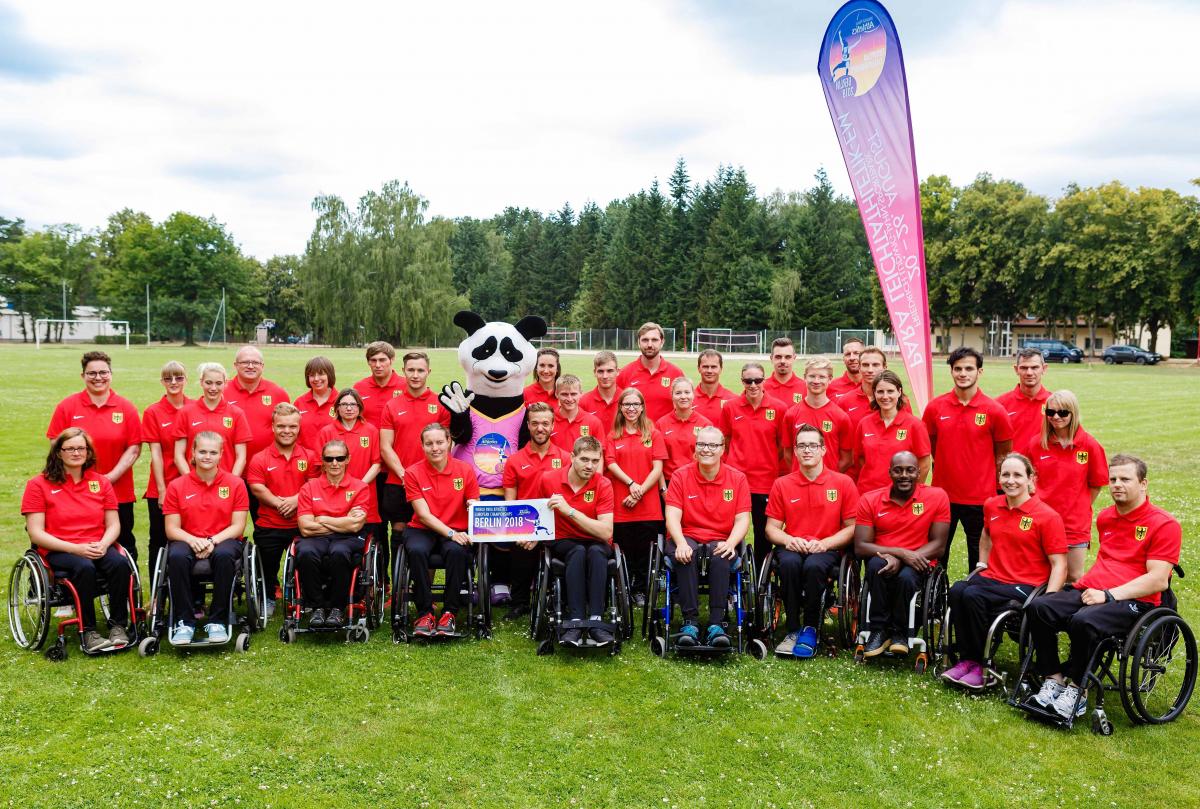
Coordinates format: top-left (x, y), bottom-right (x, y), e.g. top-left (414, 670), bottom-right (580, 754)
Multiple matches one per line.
top-left (854, 451), bottom-right (950, 658)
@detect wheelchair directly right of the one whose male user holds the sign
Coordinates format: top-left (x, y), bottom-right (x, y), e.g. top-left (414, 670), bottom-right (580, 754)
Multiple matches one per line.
top-left (642, 534), bottom-right (753, 660)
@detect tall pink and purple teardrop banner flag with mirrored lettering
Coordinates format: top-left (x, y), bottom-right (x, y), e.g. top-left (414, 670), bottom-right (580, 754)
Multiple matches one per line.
top-left (817, 0), bottom-right (934, 411)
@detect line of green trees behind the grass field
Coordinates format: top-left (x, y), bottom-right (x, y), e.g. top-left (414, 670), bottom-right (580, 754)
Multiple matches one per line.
top-left (0, 160), bottom-right (1200, 346)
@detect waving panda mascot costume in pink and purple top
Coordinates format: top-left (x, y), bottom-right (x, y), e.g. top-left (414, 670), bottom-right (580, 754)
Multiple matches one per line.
top-left (438, 311), bottom-right (546, 604)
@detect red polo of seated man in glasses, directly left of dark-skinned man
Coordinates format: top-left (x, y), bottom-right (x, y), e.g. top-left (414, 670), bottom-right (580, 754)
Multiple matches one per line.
top-left (767, 468), bottom-right (858, 539)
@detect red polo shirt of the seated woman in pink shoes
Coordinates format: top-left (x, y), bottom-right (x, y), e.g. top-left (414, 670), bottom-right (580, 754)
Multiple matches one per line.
top-left (982, 495), bottom-right (1067, 586)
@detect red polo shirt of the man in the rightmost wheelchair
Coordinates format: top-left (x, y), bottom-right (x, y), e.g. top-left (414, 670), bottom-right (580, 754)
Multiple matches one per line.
top-left (1075, 499), bottom-right (1183, 606)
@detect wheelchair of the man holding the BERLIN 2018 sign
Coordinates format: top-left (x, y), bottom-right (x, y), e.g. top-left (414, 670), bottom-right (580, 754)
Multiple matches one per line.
top-left (529, 543), bottom-right (634, 655)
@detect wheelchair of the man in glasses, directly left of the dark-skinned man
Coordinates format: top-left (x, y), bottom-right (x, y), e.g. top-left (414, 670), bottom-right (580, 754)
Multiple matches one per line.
top-left (751, 547), bottom-right (862, 655)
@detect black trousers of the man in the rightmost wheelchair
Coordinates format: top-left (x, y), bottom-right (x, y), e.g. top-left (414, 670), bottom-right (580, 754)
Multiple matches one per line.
top-left (1030, 587), bottom-right (1151, 684)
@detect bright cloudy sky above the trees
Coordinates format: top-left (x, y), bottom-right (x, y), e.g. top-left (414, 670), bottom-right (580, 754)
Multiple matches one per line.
top-left (0, 0), bottom-right (1200, 258)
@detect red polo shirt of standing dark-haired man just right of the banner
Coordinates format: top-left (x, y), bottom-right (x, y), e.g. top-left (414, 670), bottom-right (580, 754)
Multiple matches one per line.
top-left (922, 390), bottom-right (1013, 505)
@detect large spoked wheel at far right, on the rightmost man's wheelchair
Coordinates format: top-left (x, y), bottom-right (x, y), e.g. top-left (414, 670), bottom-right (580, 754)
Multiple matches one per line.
top-left (1121, 611), bottom-right (1196, 725)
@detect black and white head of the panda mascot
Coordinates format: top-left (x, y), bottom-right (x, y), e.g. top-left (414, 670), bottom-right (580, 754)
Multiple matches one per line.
top-left (454, 311), bottom-right (546, 398)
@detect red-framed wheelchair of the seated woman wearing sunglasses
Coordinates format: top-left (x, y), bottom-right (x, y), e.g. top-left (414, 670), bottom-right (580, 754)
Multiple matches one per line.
top-left (280, 534), bottom-right (386, 643)
